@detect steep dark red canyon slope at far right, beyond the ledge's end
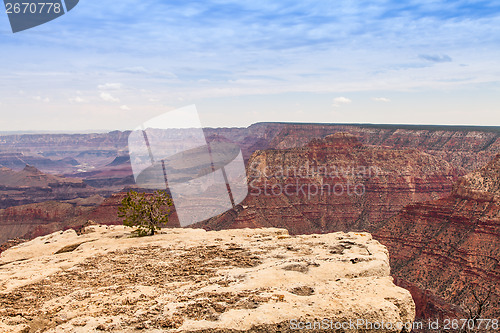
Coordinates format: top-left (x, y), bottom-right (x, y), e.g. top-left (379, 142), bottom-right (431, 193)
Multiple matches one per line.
top-left (371, 155), bottom-right (500, 318)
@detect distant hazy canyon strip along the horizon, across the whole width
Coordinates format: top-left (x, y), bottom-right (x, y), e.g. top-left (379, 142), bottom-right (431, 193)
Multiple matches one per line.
top-left (0, 123), bottom-right (500, 178)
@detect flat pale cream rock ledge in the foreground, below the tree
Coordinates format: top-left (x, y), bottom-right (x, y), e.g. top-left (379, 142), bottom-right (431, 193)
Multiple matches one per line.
top-left (0, 226), bottom-right (415, 332)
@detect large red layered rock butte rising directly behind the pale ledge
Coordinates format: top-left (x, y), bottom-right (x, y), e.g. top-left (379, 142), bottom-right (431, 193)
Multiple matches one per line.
top-left (198, 133), bottom-right (460, 234)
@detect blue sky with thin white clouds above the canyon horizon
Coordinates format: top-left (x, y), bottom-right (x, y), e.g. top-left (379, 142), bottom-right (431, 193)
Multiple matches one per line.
top-left (0, 0), bottom-right (500, 132)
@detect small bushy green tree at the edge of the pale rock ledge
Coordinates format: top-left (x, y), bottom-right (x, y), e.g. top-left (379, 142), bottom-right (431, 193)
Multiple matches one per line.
top-left (118, 191), bottom-right (172, 237)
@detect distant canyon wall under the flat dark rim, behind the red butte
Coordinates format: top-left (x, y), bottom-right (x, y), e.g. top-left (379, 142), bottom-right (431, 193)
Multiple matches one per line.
top-left (269, 124), bottom-right (500, 172)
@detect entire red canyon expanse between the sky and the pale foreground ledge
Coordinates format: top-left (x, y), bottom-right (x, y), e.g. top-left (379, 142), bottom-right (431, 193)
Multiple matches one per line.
top-left (0, 123), bottom-right (500, 318)
